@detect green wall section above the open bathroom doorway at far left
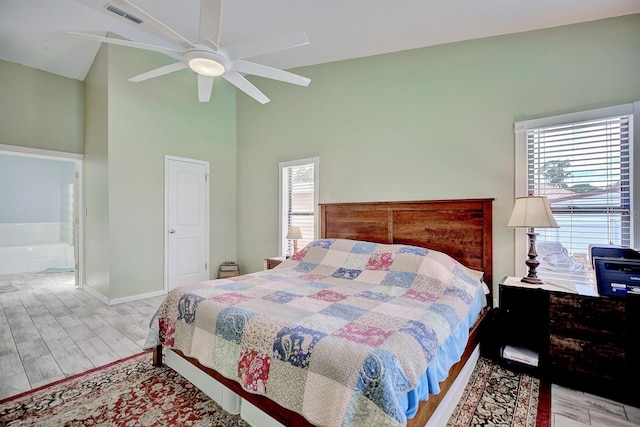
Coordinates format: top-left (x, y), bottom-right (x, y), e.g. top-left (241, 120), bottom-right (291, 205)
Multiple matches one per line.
top-left (0, 60), bottom-right (84, 153)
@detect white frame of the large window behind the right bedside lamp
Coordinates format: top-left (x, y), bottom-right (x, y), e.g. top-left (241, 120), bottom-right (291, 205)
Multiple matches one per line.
top-left (514, 101), bottom-right (640, 286)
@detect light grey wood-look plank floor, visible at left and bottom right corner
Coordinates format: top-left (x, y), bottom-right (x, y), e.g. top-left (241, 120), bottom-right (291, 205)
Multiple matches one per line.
top-left (0, 273), bottom-right (640, 427)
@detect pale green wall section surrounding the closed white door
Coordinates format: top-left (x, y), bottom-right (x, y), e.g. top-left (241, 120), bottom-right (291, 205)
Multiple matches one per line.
top-left (85, 45), bottom-right (236, 300)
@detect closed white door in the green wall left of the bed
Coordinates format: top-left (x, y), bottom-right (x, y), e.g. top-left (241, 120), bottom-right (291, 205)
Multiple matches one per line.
top-left (165, 156), bottom-right (209, 291)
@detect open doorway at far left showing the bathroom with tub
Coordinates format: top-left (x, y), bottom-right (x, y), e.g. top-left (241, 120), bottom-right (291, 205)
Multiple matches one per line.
top-left (0, 145), bottom-right (83, 287)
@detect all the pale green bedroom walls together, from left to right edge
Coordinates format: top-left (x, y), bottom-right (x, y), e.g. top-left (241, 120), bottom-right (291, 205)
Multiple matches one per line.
top-left (0, 15), bottom-right (640, 299)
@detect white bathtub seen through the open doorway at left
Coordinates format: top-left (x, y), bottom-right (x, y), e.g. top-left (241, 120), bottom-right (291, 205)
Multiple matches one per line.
top-left (0, 223), bottom-right (75, 274)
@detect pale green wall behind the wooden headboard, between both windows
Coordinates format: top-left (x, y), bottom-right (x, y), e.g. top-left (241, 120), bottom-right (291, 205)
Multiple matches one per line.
top-left (237, 15), bottom-right (640, 298)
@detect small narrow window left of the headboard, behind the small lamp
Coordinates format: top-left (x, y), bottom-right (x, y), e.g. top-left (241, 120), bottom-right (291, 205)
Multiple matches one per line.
top-left (280, 157), bottom-right (320, 255)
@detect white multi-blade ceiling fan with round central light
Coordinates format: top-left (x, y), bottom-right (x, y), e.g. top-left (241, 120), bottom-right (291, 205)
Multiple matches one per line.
top-left (71, 0), bottom-right (311, 104)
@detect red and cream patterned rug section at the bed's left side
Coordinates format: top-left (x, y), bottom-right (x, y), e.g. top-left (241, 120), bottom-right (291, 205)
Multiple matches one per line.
top-left (0, 353), bottom-right (249, 427)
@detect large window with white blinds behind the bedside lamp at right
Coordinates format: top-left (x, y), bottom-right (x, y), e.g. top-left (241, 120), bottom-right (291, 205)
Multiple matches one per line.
top-left (515, 103), bottom-right (640, 286)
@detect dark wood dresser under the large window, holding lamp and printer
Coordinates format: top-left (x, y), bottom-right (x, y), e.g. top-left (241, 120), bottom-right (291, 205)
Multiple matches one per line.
top-left (498, 281), bottom-right (640, 406)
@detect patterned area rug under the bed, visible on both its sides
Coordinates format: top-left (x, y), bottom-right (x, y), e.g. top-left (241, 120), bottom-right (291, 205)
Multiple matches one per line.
top-left (0, 354), bottom-right (549, 427)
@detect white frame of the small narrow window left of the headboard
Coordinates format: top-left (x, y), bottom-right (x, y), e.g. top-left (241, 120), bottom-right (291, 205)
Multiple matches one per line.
top-left (278, 156), bottom-right (320, 256)
